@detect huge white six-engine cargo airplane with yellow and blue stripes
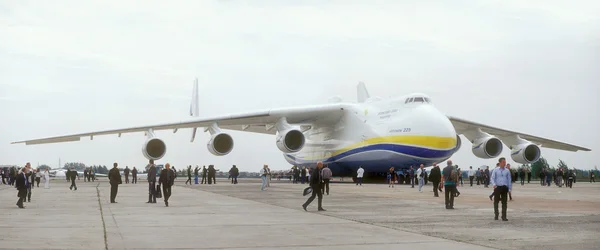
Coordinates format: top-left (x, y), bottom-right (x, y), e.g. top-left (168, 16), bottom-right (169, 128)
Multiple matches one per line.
top-left (13, 79), bottom-right (591, 176)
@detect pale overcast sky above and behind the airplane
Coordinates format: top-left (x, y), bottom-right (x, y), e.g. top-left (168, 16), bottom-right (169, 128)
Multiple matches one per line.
top-left (0, 0), bottom-right (600, 171)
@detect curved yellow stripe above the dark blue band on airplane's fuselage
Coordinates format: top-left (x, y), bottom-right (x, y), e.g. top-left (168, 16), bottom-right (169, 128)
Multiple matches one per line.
top-left (333, 135), bottom-right (456, 156)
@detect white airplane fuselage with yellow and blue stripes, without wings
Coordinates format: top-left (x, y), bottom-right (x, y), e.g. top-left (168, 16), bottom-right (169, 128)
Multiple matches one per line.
top-left (284, 94), bottom-right (460, 176)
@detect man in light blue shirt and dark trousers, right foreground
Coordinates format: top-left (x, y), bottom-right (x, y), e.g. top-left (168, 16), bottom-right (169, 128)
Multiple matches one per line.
top-left (490, 157), bottom-right (512, 221)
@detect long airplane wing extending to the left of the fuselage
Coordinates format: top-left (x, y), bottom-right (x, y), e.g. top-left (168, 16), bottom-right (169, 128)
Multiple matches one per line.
top-left (11, 104), bottom-right (345, 145)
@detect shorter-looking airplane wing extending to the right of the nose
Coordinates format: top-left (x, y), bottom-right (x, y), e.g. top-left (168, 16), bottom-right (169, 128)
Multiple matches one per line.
top-left (448, 116), bottom-right (591, 152)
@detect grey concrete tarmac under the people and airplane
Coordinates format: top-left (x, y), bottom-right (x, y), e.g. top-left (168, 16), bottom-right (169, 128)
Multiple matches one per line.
top-left (0, 178), bottom-right (600, 250)
